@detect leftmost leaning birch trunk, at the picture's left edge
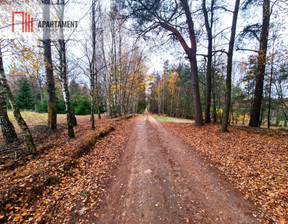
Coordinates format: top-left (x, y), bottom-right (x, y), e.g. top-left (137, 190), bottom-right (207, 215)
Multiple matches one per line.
top-left (0, 46), bottom-right (18, 144)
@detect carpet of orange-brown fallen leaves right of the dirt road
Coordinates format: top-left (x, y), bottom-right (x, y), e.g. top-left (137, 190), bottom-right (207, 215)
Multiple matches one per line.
top-left (162, 122), bottom-right (288, 223)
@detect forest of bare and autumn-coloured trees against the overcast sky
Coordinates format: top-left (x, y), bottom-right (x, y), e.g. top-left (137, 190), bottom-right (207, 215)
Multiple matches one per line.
top-left (0, 0), bottom-right (288, 152)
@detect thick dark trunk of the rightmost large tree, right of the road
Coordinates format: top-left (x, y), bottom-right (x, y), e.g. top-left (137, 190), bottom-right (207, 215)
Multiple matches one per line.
top-left (249, 0), bottom-right (270, 127)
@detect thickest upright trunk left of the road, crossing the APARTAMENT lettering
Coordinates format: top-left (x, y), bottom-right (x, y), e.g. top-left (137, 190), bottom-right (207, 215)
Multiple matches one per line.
top-left (42, 0), bottom-right (57, 130)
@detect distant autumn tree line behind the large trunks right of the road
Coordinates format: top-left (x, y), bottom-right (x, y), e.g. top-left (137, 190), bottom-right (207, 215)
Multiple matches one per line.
top-left (149, 58), bottom-right (288, 127)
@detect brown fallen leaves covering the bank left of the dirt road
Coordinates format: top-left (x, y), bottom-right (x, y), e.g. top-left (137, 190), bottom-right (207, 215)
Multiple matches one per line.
top-left (0, 117), bottom-right (136, 223)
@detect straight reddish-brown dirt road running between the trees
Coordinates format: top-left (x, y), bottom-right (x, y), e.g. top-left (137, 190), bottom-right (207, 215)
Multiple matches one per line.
top-left (95, 116), bottom-right (258, 224)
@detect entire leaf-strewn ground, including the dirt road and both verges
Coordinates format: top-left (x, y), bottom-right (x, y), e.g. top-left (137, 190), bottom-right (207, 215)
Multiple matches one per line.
top-left (0, 115), bottom-right (288, 224)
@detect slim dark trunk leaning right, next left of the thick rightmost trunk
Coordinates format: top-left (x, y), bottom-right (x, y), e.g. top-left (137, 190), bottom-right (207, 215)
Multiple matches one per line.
top-left (221, 0), bottom-right (240, 132)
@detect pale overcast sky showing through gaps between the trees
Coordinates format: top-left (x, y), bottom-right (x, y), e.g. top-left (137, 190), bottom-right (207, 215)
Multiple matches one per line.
top-left (0, 0), bottom-right (288, 86)
